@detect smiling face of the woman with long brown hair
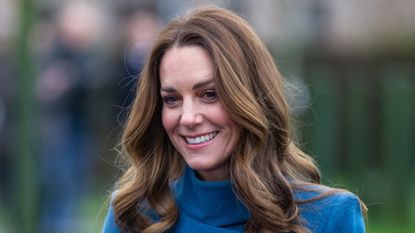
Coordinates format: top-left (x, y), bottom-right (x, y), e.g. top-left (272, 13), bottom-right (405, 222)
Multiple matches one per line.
top-left (160, 46), bottom-right (241, 180)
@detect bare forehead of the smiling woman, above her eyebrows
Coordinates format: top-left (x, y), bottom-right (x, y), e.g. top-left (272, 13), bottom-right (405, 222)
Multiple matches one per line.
top-left (160, 46), bottom-right (213, 86)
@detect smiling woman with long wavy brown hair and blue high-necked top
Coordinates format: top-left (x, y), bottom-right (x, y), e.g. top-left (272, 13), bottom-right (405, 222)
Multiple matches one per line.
top-left (103, 8), bottom-right (365, 233)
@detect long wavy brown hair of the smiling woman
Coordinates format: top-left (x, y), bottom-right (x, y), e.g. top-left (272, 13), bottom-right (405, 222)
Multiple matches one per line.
top-left (112, 7), bottom-right (320, 233)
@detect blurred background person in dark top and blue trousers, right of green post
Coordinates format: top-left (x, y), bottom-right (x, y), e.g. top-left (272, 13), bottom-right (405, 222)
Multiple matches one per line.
top-left (34, 1), bottom-right (112, 233)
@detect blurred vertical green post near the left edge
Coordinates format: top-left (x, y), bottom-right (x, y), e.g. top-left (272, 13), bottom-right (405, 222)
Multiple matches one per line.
top-left (10, 0), bottom-right (38, 233)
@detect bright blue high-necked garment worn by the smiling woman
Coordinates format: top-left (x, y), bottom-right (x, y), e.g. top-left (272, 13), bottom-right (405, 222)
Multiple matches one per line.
top-left (102, 167), bottom-right (365, 233)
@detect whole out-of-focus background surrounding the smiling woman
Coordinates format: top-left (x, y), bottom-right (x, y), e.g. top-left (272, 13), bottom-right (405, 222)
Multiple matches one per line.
top-left (0, 0), bottom-right (415, 233)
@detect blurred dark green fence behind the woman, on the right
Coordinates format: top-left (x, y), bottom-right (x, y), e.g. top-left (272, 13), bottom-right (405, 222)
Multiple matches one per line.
top-left (303, 52), bottom-right (415, 224)
